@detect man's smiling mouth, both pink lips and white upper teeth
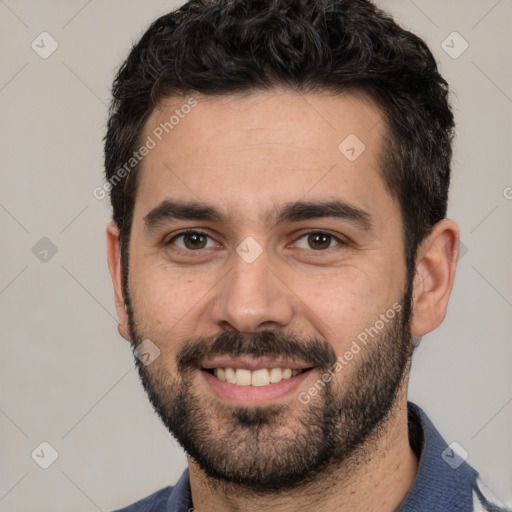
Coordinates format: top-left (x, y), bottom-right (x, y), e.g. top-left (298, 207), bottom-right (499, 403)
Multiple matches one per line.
top-left (201, 357), bottom-right (314, 405)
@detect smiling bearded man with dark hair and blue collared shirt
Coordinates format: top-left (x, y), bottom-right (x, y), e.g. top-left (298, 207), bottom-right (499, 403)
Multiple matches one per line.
top-left (105, 0), bottom-right (504, 512)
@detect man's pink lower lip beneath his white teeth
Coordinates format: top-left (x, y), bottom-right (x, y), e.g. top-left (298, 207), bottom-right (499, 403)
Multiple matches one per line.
top-left (199, 366), bottom-right (315, 406)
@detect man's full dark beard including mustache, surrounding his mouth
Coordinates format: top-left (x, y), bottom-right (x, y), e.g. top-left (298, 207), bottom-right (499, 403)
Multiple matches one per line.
top-left (128, 283), bottom-right (412, 495)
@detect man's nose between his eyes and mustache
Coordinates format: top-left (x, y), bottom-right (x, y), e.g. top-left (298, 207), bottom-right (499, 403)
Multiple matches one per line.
top-left (211, 247), bottom-right (294, 333)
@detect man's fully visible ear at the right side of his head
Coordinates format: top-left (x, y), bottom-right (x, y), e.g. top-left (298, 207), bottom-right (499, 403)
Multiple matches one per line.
top-left (411, 219), bottom-right (459, 338)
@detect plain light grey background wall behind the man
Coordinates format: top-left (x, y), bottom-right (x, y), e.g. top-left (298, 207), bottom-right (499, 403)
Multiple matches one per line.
top-left (0, 0), bottom-right (512, 512)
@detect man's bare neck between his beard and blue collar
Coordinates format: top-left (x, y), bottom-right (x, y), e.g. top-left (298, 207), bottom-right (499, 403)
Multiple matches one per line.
top-left (189, 394), bottom-right (418, 512)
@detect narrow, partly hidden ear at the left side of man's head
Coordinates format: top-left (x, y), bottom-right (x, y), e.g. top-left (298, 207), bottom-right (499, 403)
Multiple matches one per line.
top-left (107, 222), bottom-right (131, 341)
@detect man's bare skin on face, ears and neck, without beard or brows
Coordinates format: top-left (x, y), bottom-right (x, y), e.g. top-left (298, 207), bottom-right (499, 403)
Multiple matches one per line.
top-left (107, 90), bottom-right (458, 512)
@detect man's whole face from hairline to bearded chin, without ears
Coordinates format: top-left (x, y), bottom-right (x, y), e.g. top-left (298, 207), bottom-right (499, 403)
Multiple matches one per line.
top-left (118, 91), bottom-right (411, 491)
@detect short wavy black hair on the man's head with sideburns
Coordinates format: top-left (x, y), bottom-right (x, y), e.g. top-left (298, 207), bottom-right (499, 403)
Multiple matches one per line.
top-left (105, 0), bottom-right (454, 275)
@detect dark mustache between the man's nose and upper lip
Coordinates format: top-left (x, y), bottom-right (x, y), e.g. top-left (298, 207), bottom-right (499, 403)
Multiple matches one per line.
top-left (176, 331), bottom-right (336, 372)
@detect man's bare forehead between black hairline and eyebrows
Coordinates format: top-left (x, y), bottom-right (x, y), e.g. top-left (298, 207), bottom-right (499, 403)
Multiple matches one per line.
top-left (136, 90), bottom-right (390, 221)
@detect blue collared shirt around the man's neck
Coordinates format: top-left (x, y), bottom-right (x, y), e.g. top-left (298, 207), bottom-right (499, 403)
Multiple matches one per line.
top-left (116, 403), bottom-right (506, 512)
